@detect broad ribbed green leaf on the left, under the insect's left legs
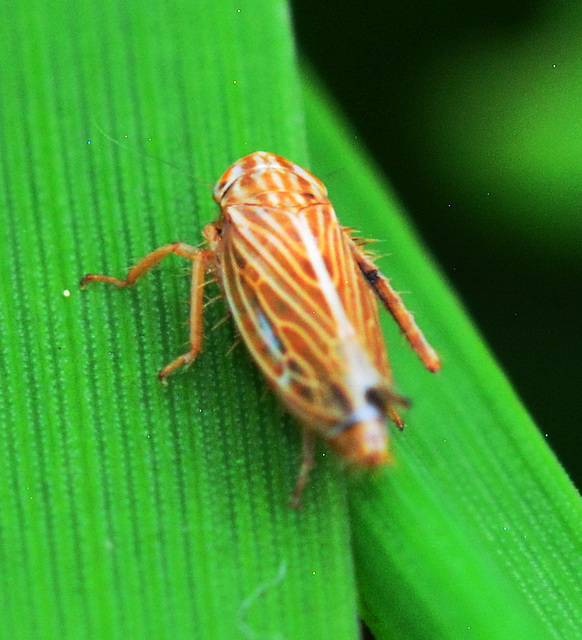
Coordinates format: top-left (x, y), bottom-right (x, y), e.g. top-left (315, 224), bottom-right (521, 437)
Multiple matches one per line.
top-left (0, 0), bottom-right (358, 640)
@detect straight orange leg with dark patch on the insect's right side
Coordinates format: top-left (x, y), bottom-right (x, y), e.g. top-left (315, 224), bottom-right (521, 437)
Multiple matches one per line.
top-left (350, 238), bottom-right (441, 372)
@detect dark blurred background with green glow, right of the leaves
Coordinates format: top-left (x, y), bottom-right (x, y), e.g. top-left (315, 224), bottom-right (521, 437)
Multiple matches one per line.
top-left (293, 0), bottom-right (582, 487)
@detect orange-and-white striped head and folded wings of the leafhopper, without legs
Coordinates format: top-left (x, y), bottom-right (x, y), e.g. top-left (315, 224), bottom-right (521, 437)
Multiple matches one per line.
top-left (214, 152), bottom-right (390, 438)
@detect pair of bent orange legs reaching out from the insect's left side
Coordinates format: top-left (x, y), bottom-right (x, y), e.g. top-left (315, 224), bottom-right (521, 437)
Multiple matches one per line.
top-left (80, 242), bottom-right (213, 380)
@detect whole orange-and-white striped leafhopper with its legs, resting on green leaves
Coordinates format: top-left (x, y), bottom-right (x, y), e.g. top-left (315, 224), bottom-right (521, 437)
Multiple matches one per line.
top-left (81, 151), bottom-right (440, 507)
